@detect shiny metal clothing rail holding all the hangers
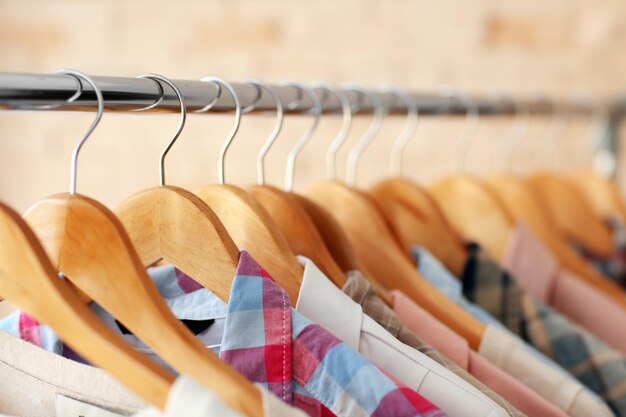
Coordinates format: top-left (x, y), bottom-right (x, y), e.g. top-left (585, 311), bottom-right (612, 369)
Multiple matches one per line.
top-left (0, 73), bottom-right (600, 115)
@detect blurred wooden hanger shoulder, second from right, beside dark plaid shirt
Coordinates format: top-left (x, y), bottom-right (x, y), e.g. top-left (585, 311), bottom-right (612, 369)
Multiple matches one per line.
top-left (528, 173), bottom-right (613, 258)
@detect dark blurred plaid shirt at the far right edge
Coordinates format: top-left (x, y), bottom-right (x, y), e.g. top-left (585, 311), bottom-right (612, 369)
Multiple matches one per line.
top-left (573, 218), bottom-right (626, 287)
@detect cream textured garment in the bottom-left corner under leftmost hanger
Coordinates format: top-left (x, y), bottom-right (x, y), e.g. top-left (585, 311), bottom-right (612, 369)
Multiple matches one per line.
top-left (0, 331), bottom-right (147, 417)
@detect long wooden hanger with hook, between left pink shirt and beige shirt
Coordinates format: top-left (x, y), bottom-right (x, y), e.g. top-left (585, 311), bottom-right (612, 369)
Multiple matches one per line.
top-left (305, 87), bottom-right (485, 349)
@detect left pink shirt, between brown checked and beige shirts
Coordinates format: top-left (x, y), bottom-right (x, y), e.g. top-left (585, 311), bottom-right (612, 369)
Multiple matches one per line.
top-left (391, 291), bottom-right (567, 417)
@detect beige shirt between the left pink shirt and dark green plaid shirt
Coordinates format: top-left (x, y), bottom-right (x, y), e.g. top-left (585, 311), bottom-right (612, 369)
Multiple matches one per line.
top-left (479, 326), bottom-right (613, 417)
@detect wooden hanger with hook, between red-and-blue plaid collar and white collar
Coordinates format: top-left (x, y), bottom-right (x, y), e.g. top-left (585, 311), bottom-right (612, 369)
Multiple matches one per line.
top-left (195, 77), bottom-right (304, 303)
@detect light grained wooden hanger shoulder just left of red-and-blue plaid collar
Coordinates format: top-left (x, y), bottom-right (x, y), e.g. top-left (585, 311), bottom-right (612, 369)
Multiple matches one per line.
top-left (115, 186), bottom-right (239, 301)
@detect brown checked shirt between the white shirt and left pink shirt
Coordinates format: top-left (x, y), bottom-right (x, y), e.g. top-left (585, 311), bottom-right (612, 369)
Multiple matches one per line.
top-left (343, 271), bottom-right (525, 417)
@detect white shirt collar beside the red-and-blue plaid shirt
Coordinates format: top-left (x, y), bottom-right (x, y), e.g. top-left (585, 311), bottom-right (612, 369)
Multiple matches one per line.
top-left (296, 256), bottom-right (363, 352)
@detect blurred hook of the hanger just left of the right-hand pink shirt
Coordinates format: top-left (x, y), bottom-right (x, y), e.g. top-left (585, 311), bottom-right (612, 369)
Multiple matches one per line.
top-left (444, 87), bottom-right (480, 172)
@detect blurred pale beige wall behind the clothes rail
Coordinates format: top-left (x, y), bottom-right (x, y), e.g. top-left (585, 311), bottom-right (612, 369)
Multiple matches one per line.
top-left (0, 0), bottom-right (626, 210)
